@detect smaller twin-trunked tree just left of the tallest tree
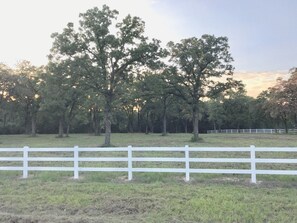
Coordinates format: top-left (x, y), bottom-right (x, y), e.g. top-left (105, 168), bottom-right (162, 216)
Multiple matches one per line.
top-left (42, 60), bottom-right (83, 137)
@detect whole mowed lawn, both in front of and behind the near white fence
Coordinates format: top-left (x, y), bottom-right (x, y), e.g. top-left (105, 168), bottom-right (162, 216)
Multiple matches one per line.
top-left (0, 134), bottom-right (297, 223)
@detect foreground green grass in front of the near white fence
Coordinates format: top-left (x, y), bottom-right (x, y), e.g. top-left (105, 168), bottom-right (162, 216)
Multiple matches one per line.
top-left (0, 175), bottom-right (297, 222)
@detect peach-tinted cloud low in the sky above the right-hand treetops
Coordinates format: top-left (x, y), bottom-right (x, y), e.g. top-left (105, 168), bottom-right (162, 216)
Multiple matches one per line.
top-left (234, 71), bottom-right (290, 97)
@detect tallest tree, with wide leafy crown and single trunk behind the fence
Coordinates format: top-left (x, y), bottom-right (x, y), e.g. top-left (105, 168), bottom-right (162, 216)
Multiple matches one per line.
top-left (52, 5), bottom-right (161, 146)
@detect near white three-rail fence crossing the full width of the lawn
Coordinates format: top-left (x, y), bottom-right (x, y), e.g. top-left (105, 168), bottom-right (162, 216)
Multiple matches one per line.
top-left (0, 146), bottom-right (297, 183)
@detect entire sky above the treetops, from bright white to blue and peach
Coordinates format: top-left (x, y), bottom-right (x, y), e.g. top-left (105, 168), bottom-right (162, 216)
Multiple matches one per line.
top-left (0, 0), bottom-right (297, 96)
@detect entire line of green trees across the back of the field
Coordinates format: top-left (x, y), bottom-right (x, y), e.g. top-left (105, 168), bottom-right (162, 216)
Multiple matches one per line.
top-left (0, 5), bottom-right (297, 145)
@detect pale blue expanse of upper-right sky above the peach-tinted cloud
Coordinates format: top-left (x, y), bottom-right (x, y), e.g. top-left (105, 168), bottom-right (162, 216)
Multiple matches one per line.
top-left (155, 0), bottom-right (297, 71)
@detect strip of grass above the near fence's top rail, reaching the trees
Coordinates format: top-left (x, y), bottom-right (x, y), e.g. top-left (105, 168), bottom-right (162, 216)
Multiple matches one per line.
top-left (0, 133), bottom-right (297, 147)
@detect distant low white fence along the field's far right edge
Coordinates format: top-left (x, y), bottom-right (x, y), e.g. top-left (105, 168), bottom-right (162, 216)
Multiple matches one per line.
top-left (207, 129), bottom-right (297, 134)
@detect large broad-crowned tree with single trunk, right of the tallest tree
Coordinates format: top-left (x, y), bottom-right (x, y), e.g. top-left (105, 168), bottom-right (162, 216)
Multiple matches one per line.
top-left (168, 35), bottom-right (234, 142)
